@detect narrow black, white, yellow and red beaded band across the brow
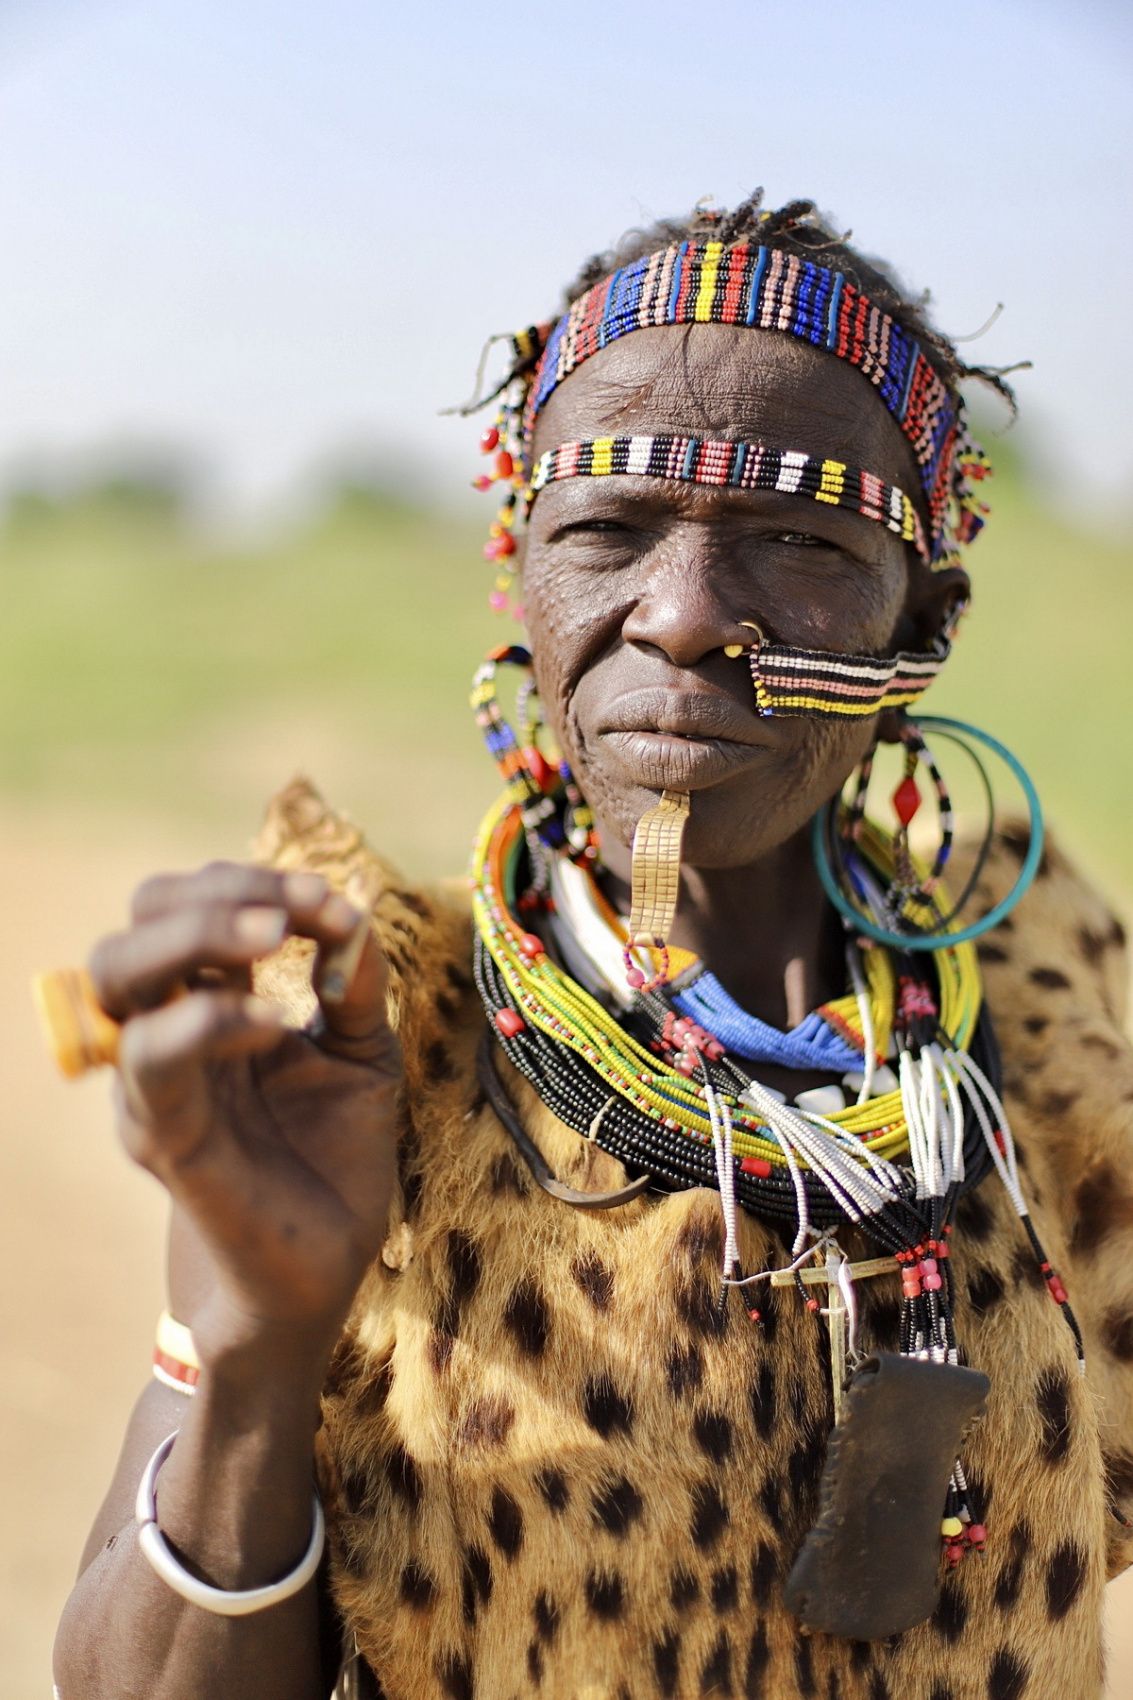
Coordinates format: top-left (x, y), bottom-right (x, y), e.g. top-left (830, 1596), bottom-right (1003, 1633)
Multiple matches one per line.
top-left (527, 437), bottom-right (929, 561)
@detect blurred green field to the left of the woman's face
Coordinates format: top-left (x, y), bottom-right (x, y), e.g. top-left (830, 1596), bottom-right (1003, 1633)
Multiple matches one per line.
top-left (0, 482), bottom-right (500, 874)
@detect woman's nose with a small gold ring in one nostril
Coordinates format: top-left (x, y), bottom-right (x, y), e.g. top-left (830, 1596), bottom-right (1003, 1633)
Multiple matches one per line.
top-left (621, 541), bottom-right (752, 666)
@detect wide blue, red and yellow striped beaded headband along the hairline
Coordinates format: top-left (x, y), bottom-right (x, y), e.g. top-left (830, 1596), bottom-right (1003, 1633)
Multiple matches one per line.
top-left (515, 241), bottom-right (990, 568)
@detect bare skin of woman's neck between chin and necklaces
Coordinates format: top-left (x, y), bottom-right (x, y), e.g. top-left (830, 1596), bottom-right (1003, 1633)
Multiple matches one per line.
top-left (601, 831), bottom-right (845, 1027)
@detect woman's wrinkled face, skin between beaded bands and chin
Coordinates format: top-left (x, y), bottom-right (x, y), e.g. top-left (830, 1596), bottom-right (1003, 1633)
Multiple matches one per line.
top-left (522, 325), bottom-right (961, 867)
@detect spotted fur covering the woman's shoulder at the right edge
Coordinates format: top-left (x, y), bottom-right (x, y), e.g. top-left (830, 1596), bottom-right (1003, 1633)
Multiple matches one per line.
top-left (961, 825), bottom-right (1133, 1576)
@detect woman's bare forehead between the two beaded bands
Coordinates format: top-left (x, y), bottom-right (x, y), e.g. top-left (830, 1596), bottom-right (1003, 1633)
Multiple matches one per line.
top-left (534, 325), bottom-right (919, 490)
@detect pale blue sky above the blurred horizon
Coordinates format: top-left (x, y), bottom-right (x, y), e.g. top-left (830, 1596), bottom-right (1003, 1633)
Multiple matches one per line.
top-left (0, 0), bottom-right (1133, 508)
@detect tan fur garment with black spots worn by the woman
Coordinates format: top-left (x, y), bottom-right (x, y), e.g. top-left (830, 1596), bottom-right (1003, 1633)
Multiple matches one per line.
top-left (260, 782), bottom-right (1133, 1700)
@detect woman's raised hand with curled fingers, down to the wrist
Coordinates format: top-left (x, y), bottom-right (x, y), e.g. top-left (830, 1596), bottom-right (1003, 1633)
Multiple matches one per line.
top-left (90, 864), bottom-right (400, 1358)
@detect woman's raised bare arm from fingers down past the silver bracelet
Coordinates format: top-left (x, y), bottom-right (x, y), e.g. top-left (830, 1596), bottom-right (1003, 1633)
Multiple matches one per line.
top-left (56, 862), bottom-right (401, 1700)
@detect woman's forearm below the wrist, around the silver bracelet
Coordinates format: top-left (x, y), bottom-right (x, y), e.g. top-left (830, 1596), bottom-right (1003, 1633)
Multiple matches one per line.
top-left (54, 1345), bottom-right (328, 1700)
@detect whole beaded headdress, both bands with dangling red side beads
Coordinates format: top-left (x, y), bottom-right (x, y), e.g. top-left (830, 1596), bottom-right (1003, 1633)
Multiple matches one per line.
top-left (476, 240), bottom-right (990, 656)
